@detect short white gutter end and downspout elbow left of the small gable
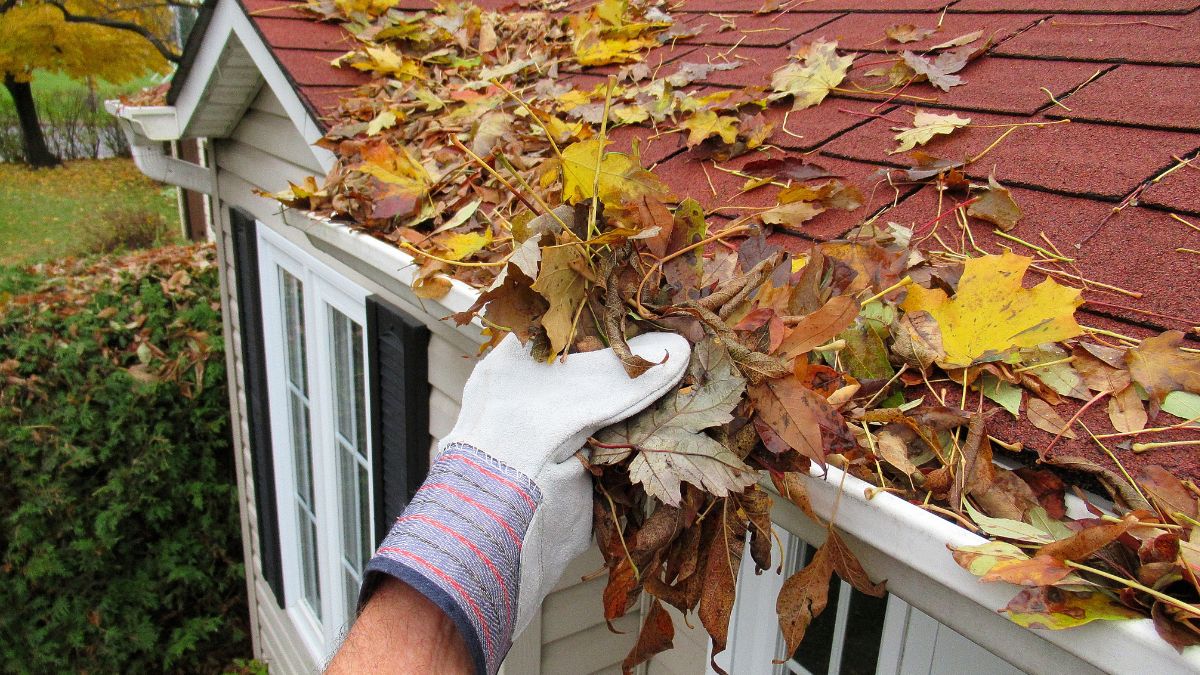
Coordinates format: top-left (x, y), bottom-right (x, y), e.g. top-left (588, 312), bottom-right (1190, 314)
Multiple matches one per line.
top-left (104, 101), bottom-right (216, 195)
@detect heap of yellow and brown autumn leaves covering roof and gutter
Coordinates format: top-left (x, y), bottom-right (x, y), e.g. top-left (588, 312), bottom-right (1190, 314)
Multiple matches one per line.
top-left (255, 0), bottom-right (1200, 670)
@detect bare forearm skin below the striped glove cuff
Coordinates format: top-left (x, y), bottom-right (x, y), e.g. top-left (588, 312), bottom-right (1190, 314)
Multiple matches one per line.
top-left (325, 578), bottom-right (474, 675)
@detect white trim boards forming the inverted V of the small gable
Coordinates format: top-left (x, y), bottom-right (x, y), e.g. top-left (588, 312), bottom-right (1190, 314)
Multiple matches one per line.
top-left (165, 0), bottom-right (337, 172)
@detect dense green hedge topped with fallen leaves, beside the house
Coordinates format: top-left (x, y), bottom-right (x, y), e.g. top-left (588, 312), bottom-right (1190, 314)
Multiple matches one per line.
top-left (0, 246), bottom-right (250, 673)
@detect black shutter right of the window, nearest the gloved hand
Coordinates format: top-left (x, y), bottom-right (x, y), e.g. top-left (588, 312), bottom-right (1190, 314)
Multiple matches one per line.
top-left (367, 295), bottom-right (431, 543)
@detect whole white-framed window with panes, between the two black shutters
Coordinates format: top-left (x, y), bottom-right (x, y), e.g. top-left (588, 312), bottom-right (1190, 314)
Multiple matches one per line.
top-left (258, 225), bottom-right (376, 662)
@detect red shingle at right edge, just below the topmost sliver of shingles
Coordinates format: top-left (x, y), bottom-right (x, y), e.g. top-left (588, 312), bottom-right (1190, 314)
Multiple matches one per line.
top-left (995, 12), bottom-right (1200, 65)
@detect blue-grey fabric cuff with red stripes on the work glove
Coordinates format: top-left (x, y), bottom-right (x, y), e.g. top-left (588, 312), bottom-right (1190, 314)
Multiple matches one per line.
top-left (359, 443), bottom-right (541, 675)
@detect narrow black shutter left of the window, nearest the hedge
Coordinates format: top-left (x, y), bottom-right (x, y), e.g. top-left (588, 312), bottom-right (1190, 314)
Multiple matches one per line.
top-left (229, 209), bottom-right (286, 607)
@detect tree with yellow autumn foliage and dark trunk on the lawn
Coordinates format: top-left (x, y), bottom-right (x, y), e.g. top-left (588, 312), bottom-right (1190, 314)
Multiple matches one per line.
top-left (0, 0), bottom-right (191, 167)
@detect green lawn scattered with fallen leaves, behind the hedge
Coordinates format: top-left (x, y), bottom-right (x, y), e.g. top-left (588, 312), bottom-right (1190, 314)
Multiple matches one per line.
top-left (0, 159), bottom-right (179, 264)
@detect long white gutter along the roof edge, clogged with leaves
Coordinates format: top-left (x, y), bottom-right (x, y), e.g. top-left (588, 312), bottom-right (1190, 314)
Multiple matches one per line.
top-left (283, 209), bottom-right (1200, 675)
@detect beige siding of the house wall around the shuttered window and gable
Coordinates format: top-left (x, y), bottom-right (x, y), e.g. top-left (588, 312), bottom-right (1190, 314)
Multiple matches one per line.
top-left (212, 86), bottom-right (643, 675)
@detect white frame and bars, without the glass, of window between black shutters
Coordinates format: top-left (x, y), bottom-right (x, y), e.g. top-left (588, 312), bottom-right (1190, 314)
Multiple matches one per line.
top-left (257, 222), bottom-right (376, 663)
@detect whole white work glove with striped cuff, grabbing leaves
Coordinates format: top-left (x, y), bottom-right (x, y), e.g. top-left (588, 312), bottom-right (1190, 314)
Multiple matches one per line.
top-left (359, 333), bottom-right (690, 674)
